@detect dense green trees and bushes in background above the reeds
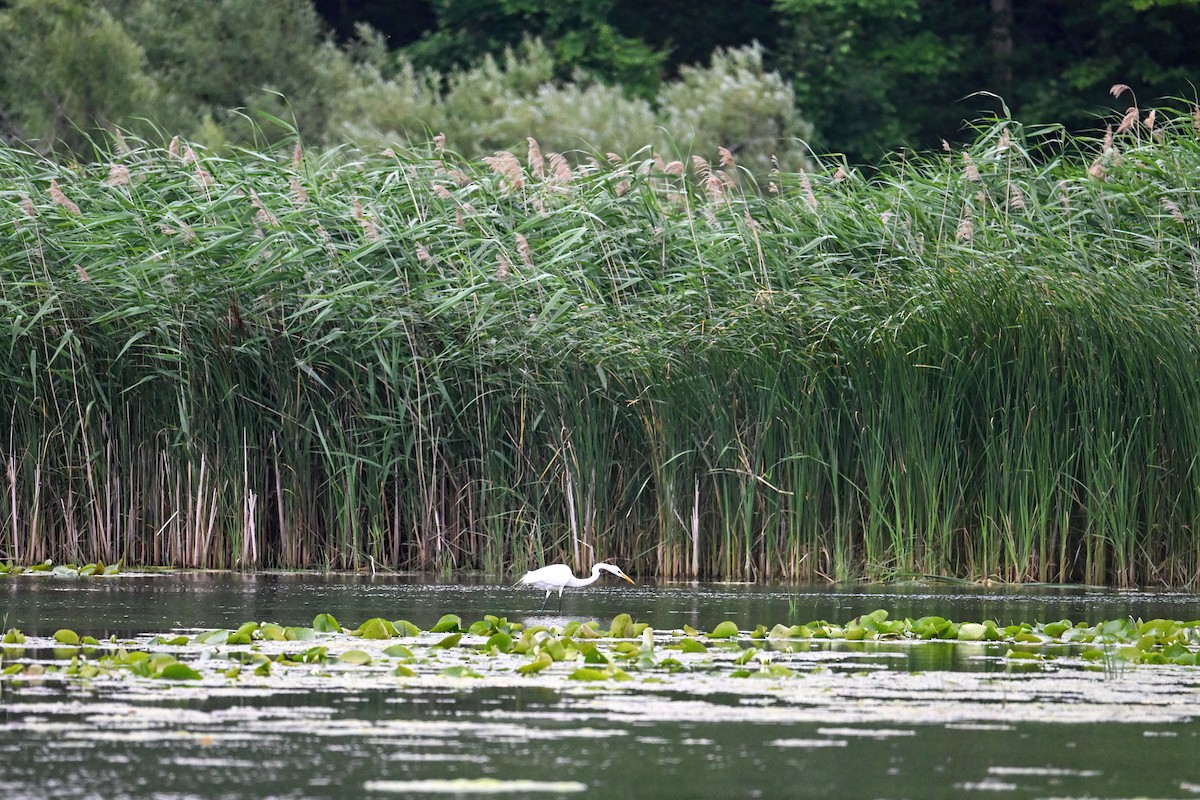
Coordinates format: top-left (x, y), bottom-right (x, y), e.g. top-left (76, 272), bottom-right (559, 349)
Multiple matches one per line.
top-left (0, 0), bottom-right (1200, 163)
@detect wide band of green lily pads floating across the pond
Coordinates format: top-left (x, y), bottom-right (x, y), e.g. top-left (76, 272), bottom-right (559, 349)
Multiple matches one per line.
top-left (0, 609), bottom-right (1200, 681)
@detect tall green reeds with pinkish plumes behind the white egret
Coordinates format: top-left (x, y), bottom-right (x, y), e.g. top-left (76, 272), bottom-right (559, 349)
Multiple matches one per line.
top-left (0, 108), bottom-right (1200, 587)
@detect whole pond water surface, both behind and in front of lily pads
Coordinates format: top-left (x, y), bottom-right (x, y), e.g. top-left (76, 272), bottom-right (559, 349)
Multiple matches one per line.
top-left (0, 573), bottom-right (1200, 800)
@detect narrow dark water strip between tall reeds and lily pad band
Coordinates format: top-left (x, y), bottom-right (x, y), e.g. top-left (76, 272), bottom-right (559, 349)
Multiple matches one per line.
top-left (0, 572), bottom-right (1200, 636)
